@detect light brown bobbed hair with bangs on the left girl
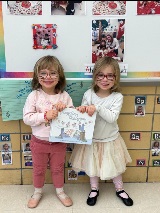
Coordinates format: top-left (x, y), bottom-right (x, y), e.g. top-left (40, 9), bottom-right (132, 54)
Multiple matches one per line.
top-left (31, 55), bottom-right (66, 93)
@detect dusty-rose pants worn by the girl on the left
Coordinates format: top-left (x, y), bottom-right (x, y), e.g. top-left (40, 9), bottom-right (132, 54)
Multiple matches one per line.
top-left (30, 135), bottom-right (66, 188)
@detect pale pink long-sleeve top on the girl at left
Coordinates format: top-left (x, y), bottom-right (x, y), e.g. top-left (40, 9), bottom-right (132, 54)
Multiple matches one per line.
top-left (23, 89), bottom-right (73, 140)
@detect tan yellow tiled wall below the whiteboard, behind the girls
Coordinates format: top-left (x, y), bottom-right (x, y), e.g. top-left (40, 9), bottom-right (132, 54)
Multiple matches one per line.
top-left (0, 86), bottom-right (160, 184)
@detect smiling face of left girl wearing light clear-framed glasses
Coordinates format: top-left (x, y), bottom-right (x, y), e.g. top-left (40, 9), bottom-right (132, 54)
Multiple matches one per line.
top-left (38, 68), bottom-right (59, 94)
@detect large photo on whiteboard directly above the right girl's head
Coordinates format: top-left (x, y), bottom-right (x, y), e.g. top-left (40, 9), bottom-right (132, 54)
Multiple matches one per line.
top-left (92, 19), bottom-right (125, 63)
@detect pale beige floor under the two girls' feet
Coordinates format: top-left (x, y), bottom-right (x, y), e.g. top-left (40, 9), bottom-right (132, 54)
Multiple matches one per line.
top-left (0, 183), bottom-right (160, 213)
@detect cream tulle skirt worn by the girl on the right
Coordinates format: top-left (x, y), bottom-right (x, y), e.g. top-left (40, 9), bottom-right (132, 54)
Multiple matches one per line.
top-left (69, 135), bottom-right (132, 180)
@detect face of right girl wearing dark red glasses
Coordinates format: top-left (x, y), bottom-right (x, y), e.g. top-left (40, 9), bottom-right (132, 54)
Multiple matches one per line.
top-left (96, 65), bottom-right (116, 93)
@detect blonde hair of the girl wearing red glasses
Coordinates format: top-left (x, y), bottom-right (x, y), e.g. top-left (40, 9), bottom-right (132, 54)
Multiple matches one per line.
top-left (92, 56), bottom-right (120, 92)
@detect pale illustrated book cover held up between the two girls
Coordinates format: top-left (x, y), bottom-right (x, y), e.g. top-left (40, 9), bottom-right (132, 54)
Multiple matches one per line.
top-left (49, 108), bottom-right (96, 144)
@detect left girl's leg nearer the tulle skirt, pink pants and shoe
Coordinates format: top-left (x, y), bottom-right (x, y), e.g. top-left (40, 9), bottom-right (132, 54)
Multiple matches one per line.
top-left (50, 143), bottom-right (73, 206)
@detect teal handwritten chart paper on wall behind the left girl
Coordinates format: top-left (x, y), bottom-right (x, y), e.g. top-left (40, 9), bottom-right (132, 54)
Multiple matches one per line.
top-left (0, 79), bottom-right (91, 121)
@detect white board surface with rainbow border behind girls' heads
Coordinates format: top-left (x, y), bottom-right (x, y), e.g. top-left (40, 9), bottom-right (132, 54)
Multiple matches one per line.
top-left (2, 1), bottom-right (160, 72)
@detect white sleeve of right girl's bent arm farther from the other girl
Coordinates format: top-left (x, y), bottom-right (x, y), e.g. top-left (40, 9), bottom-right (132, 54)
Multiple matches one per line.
top-left (95, 95), bottom-right (123, 123)
